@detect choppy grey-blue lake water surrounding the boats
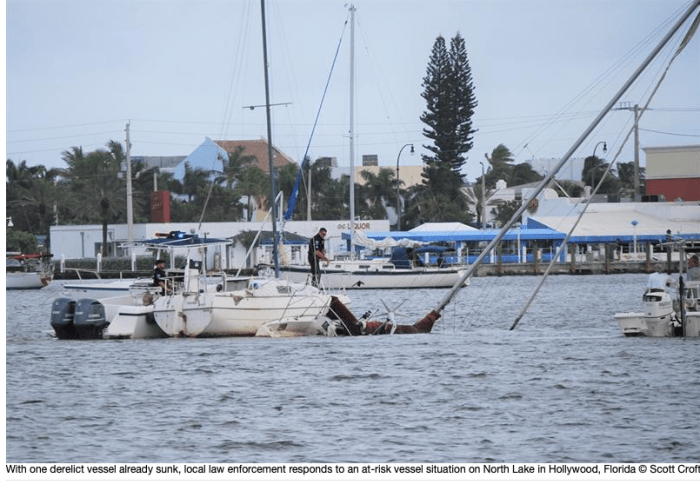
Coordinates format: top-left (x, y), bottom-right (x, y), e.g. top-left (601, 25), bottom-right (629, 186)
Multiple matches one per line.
top-left (6, 275), bottom-right (700, 463)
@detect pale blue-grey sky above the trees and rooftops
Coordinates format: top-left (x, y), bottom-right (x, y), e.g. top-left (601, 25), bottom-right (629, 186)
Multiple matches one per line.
top-left (5, 0), bottom-right (700, 181)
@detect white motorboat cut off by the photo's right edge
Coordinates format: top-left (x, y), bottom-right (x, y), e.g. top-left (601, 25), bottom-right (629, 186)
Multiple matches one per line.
top-left (614, 242), bottom-right (700, 338)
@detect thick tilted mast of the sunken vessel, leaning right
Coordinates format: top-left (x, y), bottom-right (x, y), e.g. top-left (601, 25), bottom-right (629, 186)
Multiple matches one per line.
top-left (434, 0), bottom-right (700, 320)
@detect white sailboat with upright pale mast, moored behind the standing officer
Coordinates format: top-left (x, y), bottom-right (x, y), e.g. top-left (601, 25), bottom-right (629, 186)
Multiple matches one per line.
top-left (270, 5), bottom-right (466, 290)
